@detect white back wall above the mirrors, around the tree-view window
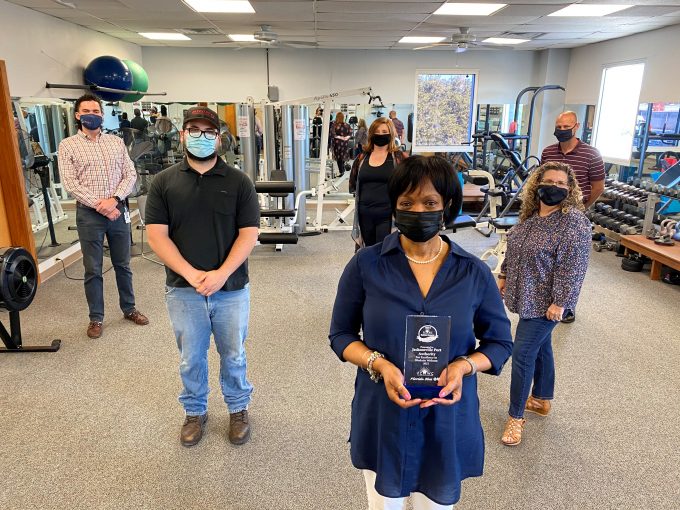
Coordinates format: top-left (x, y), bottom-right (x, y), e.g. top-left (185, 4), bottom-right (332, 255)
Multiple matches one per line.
top-left (142, 47), bottom-right (535, 104)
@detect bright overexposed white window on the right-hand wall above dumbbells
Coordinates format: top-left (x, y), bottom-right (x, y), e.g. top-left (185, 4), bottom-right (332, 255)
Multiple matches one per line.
top-left (593, 63), bottom-right (645, 165)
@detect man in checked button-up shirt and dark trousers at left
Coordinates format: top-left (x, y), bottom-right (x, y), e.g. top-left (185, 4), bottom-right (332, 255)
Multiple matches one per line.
top-left (59, 94), bottom-right (149, 338)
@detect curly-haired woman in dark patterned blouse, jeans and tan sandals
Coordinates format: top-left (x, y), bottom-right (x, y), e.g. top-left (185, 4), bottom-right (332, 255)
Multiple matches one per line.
top-left (498, 162), bottom-right (591, 446)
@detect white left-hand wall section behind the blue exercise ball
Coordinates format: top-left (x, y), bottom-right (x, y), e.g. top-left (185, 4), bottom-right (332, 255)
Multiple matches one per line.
top-left (0, 0), bottom-right (141, 97)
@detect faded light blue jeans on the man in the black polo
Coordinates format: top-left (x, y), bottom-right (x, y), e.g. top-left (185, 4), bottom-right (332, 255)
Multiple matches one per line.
top-left (165, 286), bottom-right (253, 416)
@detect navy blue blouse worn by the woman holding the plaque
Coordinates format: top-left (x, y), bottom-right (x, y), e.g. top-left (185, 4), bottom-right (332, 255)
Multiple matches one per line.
top-left (329, 232), bottom-right (512, 505)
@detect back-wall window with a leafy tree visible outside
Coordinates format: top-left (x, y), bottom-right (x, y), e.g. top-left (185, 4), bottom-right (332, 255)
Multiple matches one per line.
top-left (413, 69), bottom-right (477, 152)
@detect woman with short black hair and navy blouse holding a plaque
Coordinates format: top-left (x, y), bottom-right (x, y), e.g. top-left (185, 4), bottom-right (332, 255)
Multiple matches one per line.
top-left (329, 156), bottom-right (512, 510)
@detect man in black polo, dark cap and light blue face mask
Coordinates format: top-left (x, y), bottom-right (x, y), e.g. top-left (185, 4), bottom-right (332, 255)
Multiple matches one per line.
top-left (146, 107), bottom-right (260, 446)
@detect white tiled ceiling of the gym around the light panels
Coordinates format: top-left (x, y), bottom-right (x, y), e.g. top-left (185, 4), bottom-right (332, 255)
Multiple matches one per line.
top-left (11, 0), bottom-right (680, 51)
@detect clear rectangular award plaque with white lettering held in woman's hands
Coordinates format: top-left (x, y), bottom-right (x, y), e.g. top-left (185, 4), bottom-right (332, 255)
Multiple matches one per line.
top-left (404, 315), bottom-right (451, 398)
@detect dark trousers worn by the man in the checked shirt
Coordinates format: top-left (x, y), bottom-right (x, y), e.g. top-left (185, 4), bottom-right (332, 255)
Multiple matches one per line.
top-left (76, 204), bottom-right (135, 322)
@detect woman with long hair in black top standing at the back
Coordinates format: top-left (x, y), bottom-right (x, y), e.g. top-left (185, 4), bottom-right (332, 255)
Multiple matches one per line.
top-left (349, 117), bottom-right (404, 248)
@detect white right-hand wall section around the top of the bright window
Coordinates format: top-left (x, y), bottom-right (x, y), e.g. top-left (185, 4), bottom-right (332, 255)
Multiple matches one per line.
top-left (567, 25), bottom-right (680, 104)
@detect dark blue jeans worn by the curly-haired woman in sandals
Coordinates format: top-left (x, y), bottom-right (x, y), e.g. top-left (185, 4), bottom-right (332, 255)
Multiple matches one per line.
top-left (509, 317), bottom-right (558, 418)
